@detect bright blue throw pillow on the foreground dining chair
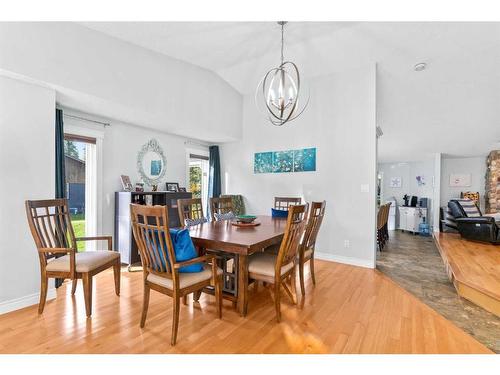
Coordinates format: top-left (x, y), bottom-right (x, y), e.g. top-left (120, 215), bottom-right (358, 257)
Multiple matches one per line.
top-left (147, 229), bottom-right (203, 273)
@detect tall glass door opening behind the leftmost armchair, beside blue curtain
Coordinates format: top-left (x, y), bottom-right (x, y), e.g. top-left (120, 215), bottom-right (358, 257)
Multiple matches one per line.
top-left (64, 134), bottom-right (97, 252)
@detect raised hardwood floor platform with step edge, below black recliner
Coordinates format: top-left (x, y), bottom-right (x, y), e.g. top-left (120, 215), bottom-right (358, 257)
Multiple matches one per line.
top-left (435, 233), bottom-right (500, 317)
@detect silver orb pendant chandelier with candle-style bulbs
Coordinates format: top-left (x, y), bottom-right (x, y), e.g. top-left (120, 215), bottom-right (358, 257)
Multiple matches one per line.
top-left (255, 21), bottom-right (309, 126)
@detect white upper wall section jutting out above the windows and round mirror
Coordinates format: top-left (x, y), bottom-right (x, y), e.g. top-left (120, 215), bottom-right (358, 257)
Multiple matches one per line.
top-left (0, 22), bottom-right (242, 141)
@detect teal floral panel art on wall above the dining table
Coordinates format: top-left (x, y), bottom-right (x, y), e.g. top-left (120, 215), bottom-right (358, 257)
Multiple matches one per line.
top-left (254, 148), bottom-right (316, 173)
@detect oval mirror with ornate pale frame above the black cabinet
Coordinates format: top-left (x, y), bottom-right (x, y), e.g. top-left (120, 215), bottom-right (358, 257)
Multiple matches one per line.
top-left (137, 139), bottom-right (167, 186)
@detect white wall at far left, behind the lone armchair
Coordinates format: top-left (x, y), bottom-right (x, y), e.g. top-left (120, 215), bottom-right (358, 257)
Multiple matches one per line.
top-left (0, 77), bottom-right (55, 314)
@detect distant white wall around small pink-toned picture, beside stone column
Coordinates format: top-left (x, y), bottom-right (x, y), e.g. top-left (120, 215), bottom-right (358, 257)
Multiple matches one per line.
top-left (441, 156), bottom-right (486, 210)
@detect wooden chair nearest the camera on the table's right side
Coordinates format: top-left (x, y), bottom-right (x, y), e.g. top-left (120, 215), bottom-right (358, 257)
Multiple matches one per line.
top-left (245, 205), bottom-right (307, 322)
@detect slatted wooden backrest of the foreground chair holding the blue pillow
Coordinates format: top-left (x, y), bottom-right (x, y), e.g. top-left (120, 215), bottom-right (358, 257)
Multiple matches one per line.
top-left (130, 204), bottom-right (176, 278)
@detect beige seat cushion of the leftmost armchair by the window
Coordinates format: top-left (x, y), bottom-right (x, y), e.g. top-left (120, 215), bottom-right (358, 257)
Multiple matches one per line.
top-left (47, 250), bottom-right (120, 272)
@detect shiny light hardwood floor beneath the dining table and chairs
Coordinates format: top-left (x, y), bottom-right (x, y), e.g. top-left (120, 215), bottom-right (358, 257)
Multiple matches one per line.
top-left (0, 261), bottom-right (491, 353)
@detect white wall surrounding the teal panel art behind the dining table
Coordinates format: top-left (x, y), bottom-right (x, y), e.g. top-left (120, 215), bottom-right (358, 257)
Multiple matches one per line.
top-left (221, 66), bottom-right (376, 267)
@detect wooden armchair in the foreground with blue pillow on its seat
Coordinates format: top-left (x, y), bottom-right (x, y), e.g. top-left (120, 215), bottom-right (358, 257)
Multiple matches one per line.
top-left (130, 204), bottom-right (222, 345)
